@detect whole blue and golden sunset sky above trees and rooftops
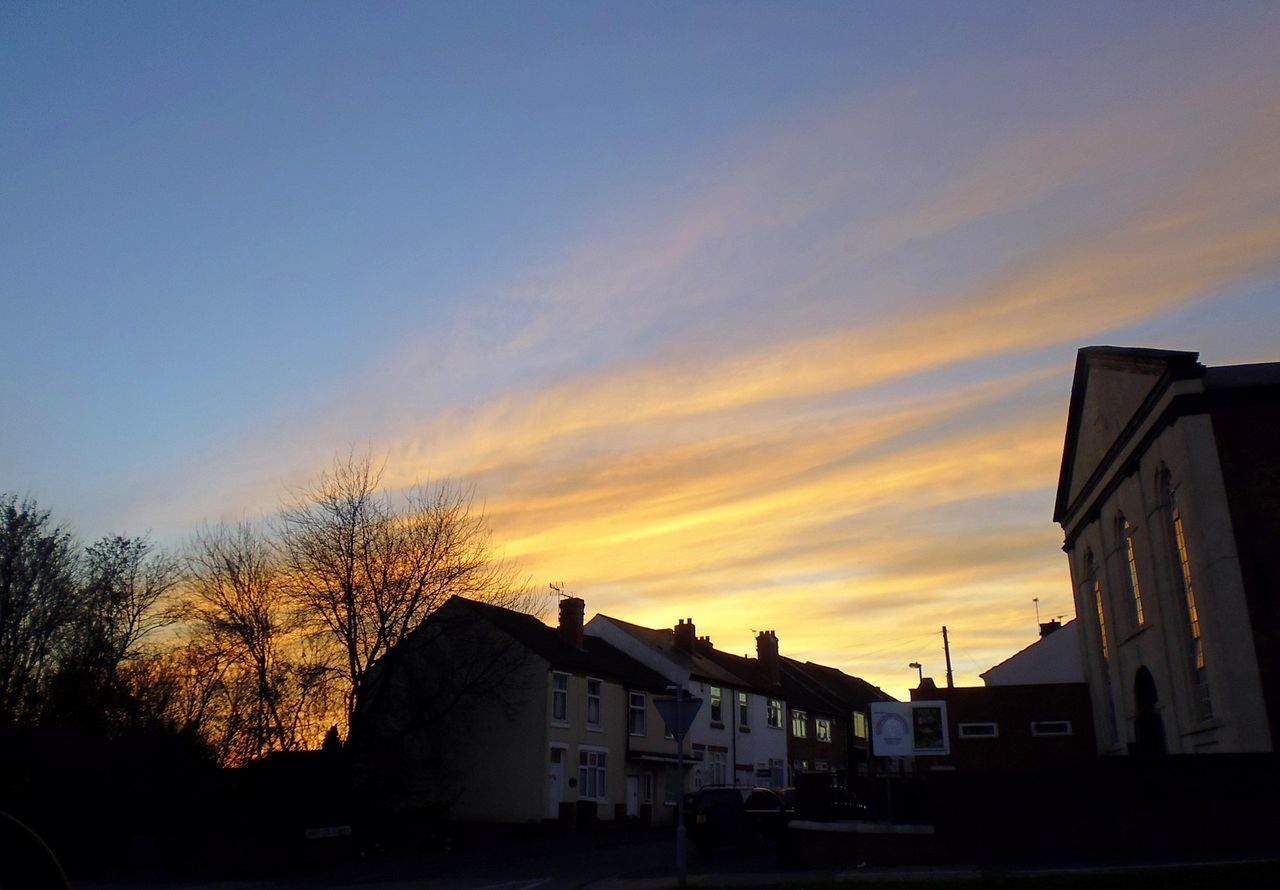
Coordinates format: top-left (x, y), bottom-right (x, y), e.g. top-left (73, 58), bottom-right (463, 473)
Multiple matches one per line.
top-left (0, 1), bottom-right (1280, 697)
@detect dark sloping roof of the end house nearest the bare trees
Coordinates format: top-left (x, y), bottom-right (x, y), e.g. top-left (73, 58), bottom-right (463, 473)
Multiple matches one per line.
top-left (442, 597), bottom-right (667, 692)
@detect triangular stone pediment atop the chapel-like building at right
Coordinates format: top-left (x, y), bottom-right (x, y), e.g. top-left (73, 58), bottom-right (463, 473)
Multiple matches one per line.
top-left (1053, 346), bottom-right (1199, 521)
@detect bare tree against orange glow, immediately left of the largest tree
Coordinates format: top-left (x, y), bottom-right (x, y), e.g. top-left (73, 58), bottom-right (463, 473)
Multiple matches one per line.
top-left (187, 524), bottom-right (333, 763)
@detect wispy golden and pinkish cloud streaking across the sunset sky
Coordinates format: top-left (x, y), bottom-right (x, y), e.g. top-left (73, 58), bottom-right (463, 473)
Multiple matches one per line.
top-left (140, 13), bottom-right (1280, 692)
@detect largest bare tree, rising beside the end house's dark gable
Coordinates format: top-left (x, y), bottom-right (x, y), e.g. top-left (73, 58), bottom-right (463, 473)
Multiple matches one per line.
top-left (279, 455), bottom-right (527, 720)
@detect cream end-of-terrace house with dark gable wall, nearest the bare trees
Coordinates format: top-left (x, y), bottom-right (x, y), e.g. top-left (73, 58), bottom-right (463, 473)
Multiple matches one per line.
top-left (352, 597), bottom-right (675, 822)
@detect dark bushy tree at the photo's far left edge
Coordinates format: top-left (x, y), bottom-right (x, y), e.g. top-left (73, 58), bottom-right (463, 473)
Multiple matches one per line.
top-left (0, 494), bottom-right (77, 726)
